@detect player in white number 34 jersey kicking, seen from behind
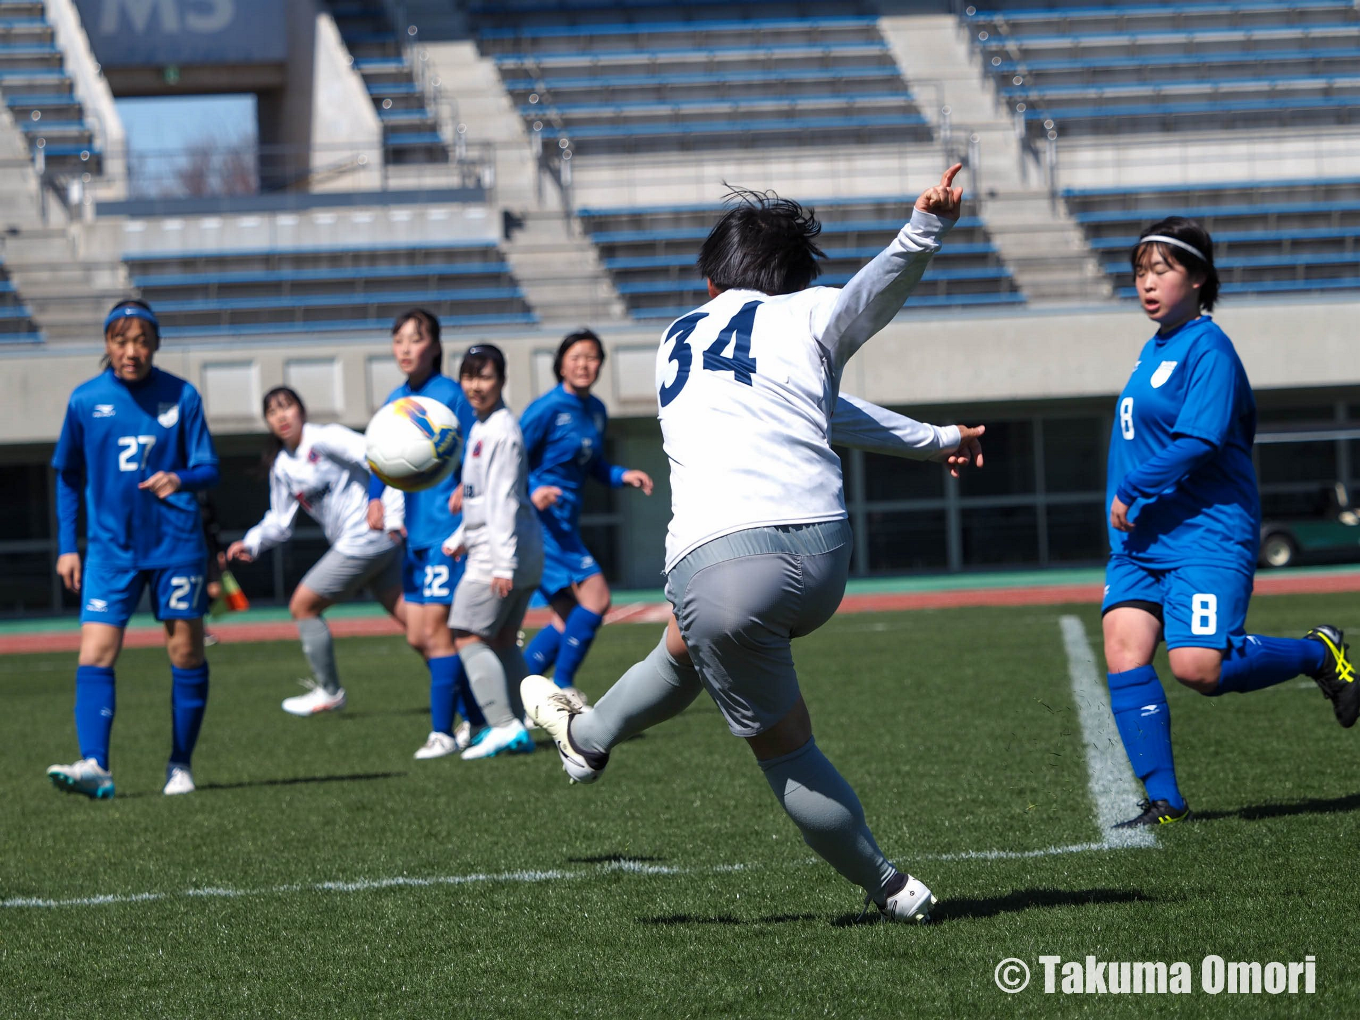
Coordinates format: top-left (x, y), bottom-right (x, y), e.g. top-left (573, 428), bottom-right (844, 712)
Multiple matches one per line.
top-left (521, 166), bottom-right (981, 919)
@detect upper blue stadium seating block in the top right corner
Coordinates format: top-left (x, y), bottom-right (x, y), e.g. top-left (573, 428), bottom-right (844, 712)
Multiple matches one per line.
top-left (966, 0), bottom-right (1360, 136)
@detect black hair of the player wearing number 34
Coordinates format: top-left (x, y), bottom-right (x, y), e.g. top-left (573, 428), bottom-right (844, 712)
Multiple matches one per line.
top-left (698, 185), bottom-right (826, 294)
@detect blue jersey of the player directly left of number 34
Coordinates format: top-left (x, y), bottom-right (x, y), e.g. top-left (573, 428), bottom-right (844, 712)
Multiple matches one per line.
top-left (520, 385), bottom-right (624, 532)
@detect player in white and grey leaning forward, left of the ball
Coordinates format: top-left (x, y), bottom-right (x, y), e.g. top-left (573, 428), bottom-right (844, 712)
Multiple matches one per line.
top-left (227, 386), bottom-right (405, 715)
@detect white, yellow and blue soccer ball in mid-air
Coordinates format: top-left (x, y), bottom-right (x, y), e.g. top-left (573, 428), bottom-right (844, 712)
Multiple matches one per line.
top-left (363, 397), bottom-right (462, 492)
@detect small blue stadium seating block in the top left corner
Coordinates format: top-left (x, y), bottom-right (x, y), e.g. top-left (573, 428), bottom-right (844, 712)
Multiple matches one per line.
top-left (0, 0), bottom-right (101, 173)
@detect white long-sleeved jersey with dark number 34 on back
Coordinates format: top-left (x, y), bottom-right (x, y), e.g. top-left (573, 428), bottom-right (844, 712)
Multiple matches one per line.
top-left (657, 211), bottom-right (959, 571)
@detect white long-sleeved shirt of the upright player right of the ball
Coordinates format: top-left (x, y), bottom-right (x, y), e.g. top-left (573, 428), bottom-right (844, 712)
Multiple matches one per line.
top-left (445, 404), bottom-right (543, 588)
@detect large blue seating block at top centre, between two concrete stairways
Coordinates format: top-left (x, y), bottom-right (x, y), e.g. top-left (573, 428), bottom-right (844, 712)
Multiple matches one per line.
top-left (473, 0), bottom-right (930, 155)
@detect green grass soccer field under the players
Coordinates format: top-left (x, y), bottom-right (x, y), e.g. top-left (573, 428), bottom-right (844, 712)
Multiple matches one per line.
top-left (0, 596), bottom-right (1360, 1019)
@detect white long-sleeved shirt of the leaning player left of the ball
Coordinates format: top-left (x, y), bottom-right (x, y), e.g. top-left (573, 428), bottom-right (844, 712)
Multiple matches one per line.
top-left (242, 423), bottom-right (405, 558)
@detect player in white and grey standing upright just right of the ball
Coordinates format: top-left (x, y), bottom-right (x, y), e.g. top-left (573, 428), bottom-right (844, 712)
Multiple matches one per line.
top-left (443, 344), bottom-right (538, 760)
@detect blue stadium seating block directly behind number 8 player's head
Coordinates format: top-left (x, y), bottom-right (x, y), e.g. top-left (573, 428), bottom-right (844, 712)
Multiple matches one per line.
top-left (1064, 178), bottom-right (1360, 298)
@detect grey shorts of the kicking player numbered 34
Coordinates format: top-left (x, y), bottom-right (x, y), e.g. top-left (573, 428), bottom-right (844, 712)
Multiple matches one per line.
top-left (666, 521), bottom-right (851, 737)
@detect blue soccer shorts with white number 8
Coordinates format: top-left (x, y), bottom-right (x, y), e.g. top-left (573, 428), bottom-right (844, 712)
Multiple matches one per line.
top-left (1100, 556), bottom-right (1254, 650)
